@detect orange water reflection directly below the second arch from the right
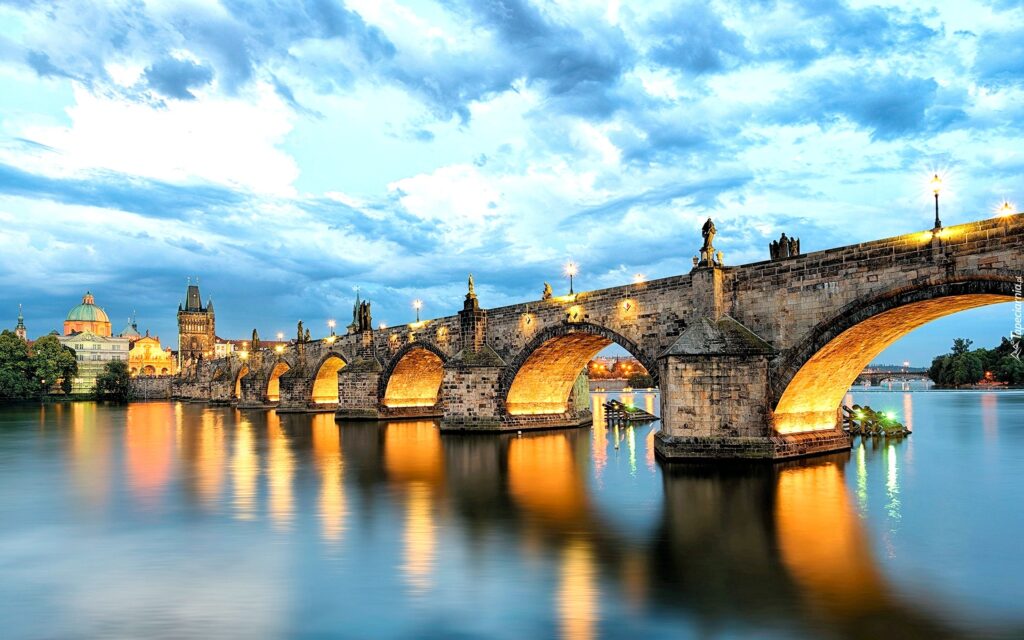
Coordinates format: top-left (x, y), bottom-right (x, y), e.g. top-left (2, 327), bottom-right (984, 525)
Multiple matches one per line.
top-left (508, 433), bottom-right (587, 524)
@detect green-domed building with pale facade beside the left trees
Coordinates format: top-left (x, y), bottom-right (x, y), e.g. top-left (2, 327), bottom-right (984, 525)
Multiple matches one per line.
top-left (57, 292), bottom-right (130, 393)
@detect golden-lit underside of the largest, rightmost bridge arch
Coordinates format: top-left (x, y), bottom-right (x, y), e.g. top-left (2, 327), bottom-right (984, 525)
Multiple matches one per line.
top-left (771, 278), bottom-right (1014, 433)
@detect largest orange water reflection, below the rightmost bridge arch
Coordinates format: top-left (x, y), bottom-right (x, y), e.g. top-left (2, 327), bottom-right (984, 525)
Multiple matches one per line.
top-left (775, 462), bottom-right (884, 614)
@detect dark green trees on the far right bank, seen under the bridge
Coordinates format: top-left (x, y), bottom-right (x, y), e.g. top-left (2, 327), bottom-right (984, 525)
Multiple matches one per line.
top-left (928, 338), bottom-right (1024, 387)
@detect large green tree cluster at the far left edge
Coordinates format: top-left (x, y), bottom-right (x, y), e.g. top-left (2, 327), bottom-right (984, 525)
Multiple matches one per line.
top-left (0, 330), bottom-right (78, 400)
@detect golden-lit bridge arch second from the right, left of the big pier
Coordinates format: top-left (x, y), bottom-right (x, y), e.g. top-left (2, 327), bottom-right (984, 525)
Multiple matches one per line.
top-left (499, 323), bottom-right (658, 416)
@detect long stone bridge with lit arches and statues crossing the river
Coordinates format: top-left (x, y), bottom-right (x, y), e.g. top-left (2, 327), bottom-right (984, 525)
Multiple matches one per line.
top-left (176, 214), bottom-right (1024, 459)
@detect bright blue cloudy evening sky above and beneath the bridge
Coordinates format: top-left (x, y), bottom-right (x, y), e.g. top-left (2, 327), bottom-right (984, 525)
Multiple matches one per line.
top-left (0, 0), bottom-right (1024, 365)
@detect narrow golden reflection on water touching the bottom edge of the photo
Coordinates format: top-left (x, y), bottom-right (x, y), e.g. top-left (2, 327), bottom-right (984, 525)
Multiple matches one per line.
top-left (558, 538), bottom-right (600, 640)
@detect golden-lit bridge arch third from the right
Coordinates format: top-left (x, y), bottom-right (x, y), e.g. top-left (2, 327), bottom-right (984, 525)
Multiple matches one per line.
top-left (377, 341), bottom-right (449, 408)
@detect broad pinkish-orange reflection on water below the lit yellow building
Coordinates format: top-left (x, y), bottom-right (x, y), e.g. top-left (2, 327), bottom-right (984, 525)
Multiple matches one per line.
top-left (124, 402), bottom-right (176, 507)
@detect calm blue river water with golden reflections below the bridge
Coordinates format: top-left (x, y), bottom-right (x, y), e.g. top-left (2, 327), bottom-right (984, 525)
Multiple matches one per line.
top-left (0, 391), bottom-right (1024, 639)
